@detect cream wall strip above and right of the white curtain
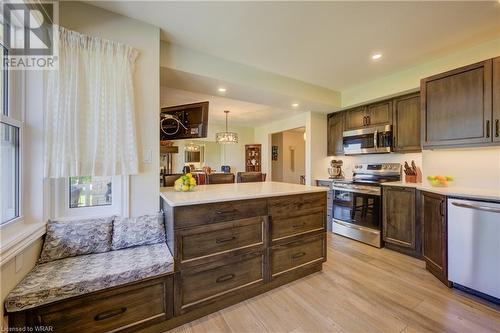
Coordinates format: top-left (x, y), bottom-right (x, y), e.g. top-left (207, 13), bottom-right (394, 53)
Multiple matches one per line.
top-left (59, 1), bottom-right (160, 216)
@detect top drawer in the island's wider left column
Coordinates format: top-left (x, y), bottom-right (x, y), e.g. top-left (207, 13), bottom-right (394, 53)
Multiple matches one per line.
top-left (174, 199), bottom-right (267, 229)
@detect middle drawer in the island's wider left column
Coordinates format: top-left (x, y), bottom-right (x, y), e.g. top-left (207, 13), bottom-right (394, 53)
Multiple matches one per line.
top-left (179, 217), bottom-right (265, 262)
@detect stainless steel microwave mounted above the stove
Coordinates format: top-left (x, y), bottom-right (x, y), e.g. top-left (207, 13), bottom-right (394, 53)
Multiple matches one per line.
top-left (343, 125), bottom-right (392, 155)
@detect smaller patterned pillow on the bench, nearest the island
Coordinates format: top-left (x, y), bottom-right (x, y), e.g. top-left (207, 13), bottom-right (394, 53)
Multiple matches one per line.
top-left (111, 213), bottom-right (165, 250)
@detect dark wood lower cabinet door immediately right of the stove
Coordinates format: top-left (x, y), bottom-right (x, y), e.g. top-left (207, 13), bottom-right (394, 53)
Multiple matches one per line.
top-left (383, 186), bottom-right (417, 250)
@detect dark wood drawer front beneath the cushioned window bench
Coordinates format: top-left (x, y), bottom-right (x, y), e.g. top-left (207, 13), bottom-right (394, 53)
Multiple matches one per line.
top-left (34, 277), bottom-right (173, 332)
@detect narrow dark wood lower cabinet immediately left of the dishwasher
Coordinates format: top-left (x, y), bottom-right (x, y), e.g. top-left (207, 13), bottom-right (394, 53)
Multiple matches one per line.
top-left (420, 191), bottom-right (450, 286)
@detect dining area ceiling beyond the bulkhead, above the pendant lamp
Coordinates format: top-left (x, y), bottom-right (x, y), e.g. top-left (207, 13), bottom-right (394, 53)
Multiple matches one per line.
top-left (160, 87), bottom-right (300, 128)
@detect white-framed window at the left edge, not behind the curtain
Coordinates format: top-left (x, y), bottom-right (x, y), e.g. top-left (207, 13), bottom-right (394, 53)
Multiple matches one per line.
top-left (0, 44), bottom-right (21, 224)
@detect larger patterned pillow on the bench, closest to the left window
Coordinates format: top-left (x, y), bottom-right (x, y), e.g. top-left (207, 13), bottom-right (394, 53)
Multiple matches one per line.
top-left (38, 216), bottom-right (114, 263)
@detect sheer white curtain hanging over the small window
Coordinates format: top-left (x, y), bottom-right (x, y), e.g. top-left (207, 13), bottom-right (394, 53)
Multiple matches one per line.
top-left (44, 27), bottom-right (138, 178)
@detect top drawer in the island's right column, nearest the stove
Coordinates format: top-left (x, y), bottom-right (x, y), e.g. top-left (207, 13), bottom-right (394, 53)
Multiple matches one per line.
top-left (269, 191), bottom-right (326, 218)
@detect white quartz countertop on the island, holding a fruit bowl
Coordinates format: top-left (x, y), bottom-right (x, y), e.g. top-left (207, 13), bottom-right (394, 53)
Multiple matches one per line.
top-left (160, 182), bottom-right (328, 207)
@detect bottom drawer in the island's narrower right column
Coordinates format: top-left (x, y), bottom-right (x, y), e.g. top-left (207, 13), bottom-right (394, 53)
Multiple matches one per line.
top-left (271, 234), bottom-right (326, 278)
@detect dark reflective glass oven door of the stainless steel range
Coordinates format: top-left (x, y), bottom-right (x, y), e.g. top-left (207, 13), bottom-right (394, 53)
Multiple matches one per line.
top-left (333, 189), bottom-right (381, 231)
